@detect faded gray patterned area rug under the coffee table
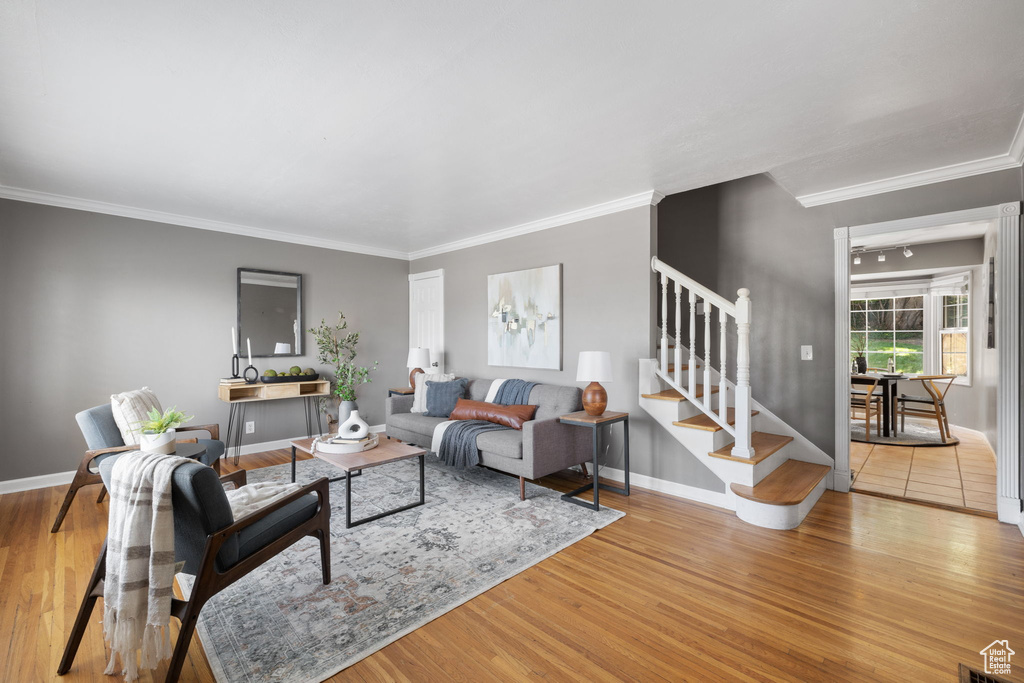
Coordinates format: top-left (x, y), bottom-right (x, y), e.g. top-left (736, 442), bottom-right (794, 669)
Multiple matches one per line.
top-left (178, 456), bottom-right (624, 683)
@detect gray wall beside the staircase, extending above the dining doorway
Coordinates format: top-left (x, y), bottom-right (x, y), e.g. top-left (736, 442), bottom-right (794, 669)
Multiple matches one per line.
top-left (658, 164), bottom-right (1024, 454)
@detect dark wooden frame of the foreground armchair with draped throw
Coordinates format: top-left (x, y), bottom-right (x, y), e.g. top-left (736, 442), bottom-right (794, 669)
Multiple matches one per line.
top-left (57, 470), bottom-right (331, 683)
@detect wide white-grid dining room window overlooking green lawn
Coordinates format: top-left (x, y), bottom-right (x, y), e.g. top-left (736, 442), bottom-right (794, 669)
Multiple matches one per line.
top-left (850, 296), bottom-right (925, 374)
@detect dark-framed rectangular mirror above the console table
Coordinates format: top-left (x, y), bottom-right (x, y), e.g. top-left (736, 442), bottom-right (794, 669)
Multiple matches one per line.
top-left (239, 268), bottom-right (304, 358)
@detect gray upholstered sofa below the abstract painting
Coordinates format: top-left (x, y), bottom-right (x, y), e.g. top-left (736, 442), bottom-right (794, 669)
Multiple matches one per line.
top-left (386, 380), bottom-right (594, 499)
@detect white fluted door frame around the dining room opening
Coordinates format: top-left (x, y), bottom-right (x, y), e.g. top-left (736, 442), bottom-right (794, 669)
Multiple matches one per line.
top-left (834, 202), bottom-right (1024, 526)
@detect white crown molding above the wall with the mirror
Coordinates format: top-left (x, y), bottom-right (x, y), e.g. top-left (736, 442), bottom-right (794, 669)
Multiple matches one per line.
top-left (0, 185), bottom-right (409, 261)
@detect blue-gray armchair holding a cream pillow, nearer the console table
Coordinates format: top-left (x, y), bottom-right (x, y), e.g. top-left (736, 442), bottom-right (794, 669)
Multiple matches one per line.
top-left (50, 403), bottom-right (224, 533)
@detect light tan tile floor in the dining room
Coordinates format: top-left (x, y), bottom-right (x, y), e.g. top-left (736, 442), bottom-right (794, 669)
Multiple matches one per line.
top-left (850, 427), bottom-right (995, 512)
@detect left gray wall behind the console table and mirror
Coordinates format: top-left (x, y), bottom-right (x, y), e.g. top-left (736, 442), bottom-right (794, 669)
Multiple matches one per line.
top-left (0, 200), bottom-right (409, 480)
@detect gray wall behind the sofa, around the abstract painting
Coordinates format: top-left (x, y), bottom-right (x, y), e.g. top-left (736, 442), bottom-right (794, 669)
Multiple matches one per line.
top-left (411, 207), bottom-right (722, 490)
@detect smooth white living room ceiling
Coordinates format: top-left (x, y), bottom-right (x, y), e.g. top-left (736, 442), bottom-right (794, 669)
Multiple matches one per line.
top-left (0, 0), bottom-right (1024, 254)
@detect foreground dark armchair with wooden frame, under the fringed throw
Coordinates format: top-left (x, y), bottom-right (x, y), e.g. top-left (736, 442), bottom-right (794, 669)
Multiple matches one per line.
top-left (57, 456), bottom-right (331, 681)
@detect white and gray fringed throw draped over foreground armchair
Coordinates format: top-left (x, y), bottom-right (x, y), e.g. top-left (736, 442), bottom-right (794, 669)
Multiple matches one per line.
top-left (103, 453), bottom-right (193, 681)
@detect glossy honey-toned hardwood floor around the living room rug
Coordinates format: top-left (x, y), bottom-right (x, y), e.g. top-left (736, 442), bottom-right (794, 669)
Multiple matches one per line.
top-left (0, 451), bottom-right (1024, 683)
